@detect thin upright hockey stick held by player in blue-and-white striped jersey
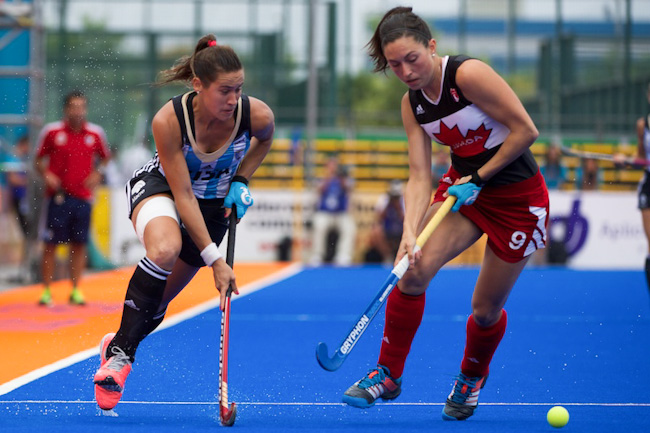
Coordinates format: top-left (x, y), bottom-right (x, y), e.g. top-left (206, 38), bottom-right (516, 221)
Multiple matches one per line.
top-left (219, 206), bottom-right (237, 427)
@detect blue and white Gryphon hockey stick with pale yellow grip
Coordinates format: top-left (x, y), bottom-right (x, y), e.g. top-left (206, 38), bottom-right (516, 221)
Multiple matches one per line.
top-left (316, 196), bottom-right (456, 371)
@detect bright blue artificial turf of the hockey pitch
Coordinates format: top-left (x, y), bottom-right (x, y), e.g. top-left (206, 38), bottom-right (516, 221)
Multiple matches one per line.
top-left (0, 266), bottom-right (650, 433)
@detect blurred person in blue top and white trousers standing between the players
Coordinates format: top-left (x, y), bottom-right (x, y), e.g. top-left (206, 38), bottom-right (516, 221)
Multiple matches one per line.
top-left (311, 156), bottom-right (356, 265)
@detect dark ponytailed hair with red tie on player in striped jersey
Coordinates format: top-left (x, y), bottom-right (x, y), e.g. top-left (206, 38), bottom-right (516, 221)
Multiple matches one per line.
top-left (156, 34), bottom-right (243, 86)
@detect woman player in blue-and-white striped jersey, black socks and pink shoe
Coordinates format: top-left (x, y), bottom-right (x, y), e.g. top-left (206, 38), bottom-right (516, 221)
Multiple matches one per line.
top-left (94, 35), bottom-right (275, 410)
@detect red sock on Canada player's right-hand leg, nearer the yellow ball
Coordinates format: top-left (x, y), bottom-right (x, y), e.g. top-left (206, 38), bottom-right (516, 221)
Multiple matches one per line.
top-left (460, 310), bottom-right (508, 377)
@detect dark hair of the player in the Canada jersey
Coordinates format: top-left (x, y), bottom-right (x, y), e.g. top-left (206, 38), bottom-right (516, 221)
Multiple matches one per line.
top-left (366, 6), bottom-right (433, 72)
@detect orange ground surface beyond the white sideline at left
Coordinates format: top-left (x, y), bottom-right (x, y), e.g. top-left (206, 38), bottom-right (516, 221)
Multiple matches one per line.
top-left (0, 263), bottom-right (289, 384)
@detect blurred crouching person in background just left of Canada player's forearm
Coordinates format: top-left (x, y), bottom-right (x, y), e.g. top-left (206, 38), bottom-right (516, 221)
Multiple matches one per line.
top-left (365, 180), bottom-right (404, 263)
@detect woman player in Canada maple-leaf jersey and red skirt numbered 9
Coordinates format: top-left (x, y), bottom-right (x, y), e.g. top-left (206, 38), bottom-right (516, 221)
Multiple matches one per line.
top-left (343, 7), bottom-right (549, 420)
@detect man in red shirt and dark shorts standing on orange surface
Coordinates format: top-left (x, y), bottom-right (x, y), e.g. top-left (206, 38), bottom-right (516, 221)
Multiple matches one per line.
top-left (34, 91), bottom-right (110, 305)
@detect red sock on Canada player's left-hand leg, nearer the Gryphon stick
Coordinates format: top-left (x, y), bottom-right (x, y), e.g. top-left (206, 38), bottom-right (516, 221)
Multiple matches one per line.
top-left (378, 287), bottom-right (425, 379)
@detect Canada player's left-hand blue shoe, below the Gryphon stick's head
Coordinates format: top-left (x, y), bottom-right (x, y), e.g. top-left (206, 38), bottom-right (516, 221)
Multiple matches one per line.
top-left (343, 365), bottom-right (402, 408)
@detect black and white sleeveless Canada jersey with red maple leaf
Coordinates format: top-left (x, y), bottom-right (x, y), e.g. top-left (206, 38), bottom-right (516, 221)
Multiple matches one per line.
top-left (409, 56), bottom-right (539, 185)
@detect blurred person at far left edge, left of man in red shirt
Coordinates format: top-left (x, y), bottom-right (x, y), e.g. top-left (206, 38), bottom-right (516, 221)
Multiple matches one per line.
top-left (4, 135), bottom-right (29, 236)
